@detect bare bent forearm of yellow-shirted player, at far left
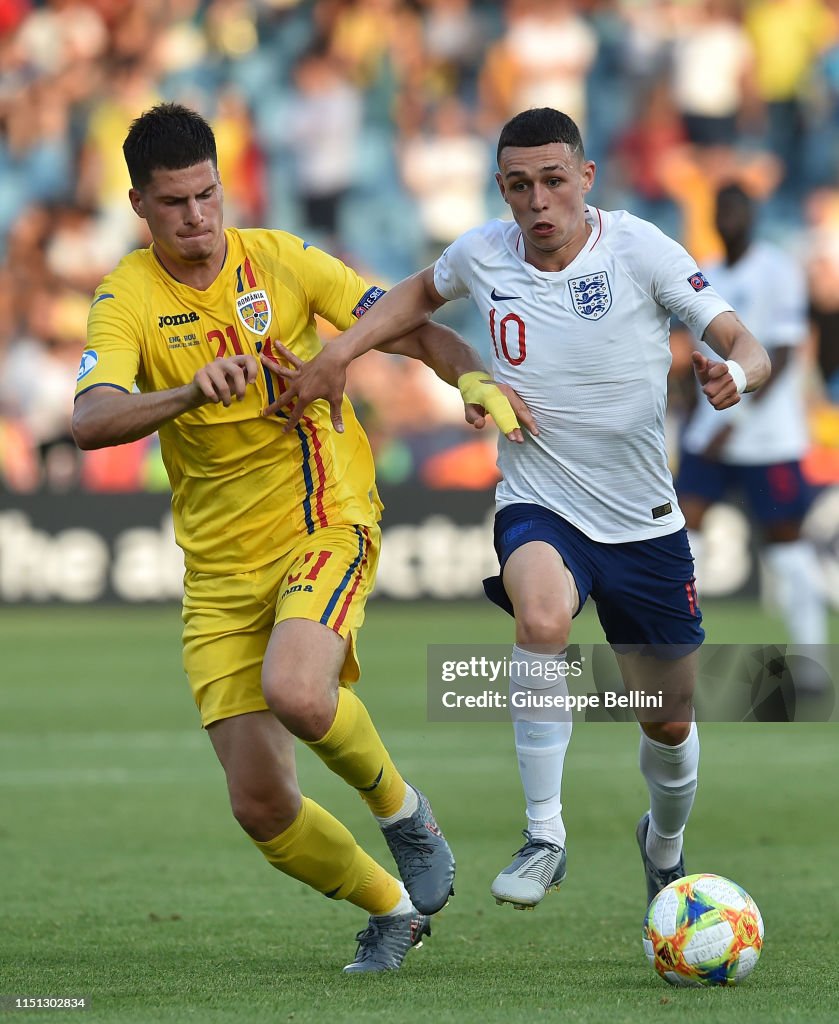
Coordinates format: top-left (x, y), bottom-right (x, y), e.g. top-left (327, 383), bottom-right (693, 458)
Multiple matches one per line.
top-left (73, 355), bottom-right (259, 451)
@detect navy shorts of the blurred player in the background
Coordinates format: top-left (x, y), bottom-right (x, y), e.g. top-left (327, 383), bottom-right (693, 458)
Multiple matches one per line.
top-left (676, 452), bottom-right (814, 526)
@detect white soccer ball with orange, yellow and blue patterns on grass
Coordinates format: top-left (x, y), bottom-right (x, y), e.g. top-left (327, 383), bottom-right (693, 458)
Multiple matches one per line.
top-left (643, 874), bottom-right (763, 986)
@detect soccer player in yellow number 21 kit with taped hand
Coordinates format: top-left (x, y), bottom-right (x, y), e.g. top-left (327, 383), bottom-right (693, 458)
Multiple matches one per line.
top-left (73, 103), bottom-right (528, 972)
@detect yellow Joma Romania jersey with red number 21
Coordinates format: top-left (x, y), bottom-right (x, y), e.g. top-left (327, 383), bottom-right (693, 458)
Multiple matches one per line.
top-left (76, 228), bottom-right (383, 573)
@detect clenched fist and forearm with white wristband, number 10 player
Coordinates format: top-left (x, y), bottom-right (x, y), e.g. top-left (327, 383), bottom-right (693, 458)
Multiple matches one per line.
top-left (691, 312), bottom-right (771, 409)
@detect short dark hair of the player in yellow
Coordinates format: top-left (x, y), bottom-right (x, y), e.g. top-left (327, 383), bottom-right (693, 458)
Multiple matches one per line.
top-left (122, 103), bottom-right (218, 188)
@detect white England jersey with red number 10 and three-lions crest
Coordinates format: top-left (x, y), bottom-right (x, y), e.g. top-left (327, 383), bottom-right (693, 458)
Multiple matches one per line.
top-left (434, 207), bottom-right (731, 544)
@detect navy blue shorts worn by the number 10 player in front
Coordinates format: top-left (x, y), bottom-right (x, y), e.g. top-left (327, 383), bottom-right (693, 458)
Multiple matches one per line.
top-left (484, 504), bottom-right (705, 657)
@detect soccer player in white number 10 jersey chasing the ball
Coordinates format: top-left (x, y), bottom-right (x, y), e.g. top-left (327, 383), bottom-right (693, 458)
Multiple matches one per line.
top-left (266, 108), bottom-right (769, 907)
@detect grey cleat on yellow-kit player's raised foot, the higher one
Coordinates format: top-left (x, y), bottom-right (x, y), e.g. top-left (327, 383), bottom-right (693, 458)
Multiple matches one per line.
top-left (382, 785), bottom-right (455, 914)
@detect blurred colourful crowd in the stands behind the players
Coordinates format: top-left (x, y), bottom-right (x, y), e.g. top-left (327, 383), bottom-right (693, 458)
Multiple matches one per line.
top-left (0, 0), bottom-right (839, 492)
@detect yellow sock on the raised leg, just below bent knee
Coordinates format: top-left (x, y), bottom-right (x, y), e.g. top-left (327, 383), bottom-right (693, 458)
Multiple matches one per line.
top-left (308, 686), bottom-right (406, 818)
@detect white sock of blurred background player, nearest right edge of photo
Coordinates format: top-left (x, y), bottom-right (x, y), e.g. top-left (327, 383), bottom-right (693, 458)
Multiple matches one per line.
top-left (763, 540), bottom-right (828, 644)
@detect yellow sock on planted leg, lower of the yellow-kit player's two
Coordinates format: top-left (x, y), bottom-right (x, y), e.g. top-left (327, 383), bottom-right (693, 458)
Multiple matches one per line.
top-left (252, 794), bottom-right (403, 914)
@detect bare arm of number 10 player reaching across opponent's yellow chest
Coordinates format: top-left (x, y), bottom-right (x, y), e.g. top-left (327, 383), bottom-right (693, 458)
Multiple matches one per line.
top-left (262, 266), bottom-right (446, 433)
